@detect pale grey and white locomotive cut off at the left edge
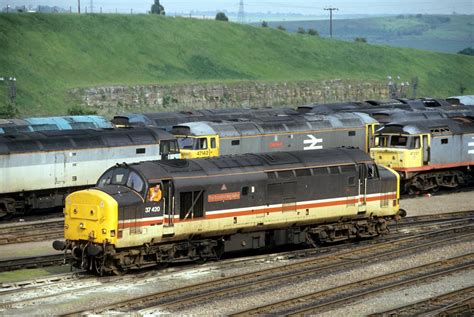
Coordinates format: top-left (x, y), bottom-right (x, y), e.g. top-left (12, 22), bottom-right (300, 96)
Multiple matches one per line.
top-left (0, 128), bottom-right (179, 218)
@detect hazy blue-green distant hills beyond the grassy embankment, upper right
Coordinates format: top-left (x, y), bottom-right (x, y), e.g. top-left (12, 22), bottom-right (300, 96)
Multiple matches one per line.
top-left (262, 14), bottom-right (474, 53)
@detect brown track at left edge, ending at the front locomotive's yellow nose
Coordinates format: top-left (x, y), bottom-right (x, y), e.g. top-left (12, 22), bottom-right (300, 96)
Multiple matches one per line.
top-left (0, 219), bottom-right (64, 245)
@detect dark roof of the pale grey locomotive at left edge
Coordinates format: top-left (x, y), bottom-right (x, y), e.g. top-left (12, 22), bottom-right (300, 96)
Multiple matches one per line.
top-left (0, 128), bottom-right (175, 154)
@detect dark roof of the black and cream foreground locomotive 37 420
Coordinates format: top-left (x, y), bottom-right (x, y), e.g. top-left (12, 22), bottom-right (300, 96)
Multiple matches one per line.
top-left (125, 148), bottom-right (372, 183)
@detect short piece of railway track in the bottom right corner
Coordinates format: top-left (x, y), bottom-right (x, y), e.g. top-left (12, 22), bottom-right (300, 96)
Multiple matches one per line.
top-left (369, 286), bottom-right (474, 317)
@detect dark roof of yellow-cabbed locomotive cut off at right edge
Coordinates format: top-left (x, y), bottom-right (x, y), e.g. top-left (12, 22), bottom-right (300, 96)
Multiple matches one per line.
top-left (377, 118), bottom-right (474, 134)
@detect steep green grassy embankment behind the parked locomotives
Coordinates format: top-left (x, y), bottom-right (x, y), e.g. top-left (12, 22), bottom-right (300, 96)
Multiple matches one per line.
top-left (0, 14), bottom-right (474, 115)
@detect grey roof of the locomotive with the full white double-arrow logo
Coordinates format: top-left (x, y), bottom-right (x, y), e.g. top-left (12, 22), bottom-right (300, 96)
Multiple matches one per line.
top-left (172, 113), bottom-right (377, 137)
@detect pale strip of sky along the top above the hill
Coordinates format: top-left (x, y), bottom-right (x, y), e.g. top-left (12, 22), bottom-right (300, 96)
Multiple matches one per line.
top-left (0, 0), bottom-right (474, 15)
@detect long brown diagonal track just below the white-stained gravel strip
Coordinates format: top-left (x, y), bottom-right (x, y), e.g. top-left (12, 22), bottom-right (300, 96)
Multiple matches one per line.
top-left (61, 222), bottom-right (474, 314)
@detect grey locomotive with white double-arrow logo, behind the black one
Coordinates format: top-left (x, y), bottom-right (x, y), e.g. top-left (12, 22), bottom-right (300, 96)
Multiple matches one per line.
top-left (171, 113), bottom-right (377, 158)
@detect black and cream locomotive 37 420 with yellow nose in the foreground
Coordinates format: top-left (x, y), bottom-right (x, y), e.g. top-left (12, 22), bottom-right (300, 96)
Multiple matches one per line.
top-left (53, 148), bottom-right (405, 274)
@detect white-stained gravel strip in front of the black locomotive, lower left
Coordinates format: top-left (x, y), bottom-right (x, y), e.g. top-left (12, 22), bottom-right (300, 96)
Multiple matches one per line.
top-left (0, 256), bottom-right (296, 316)
